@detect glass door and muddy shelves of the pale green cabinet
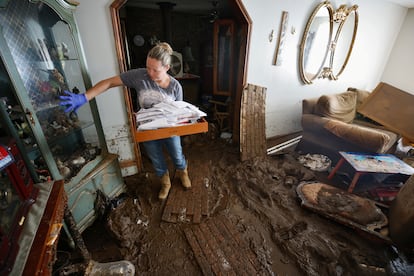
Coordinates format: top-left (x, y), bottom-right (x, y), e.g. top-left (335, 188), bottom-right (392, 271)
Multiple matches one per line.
top-left (0, 0), bottom-right (106, 180)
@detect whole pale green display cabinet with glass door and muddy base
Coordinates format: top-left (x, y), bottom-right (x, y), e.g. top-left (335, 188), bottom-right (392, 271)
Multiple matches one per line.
top-left (0, 0), bottom-right (124, 237)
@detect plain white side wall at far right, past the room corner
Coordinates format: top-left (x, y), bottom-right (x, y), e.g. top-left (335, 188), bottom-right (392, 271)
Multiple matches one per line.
top-left (381, 9), bottom-right (414, 94)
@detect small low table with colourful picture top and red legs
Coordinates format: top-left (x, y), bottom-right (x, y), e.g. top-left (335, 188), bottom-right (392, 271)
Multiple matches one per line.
top-left (328, 151), bottom-right (414, 193)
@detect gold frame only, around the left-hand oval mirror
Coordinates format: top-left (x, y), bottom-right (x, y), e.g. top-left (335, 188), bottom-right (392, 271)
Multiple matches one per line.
top-left (299, 1), bottom-right (333, 84)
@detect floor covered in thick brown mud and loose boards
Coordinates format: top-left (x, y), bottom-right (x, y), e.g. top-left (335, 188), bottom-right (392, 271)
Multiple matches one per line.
top-left (77, 135), bottom-right (412, 275)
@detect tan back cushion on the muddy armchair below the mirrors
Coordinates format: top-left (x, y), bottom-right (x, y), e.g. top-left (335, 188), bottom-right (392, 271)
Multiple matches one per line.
top-left (315, 91), bottom-right (357, 123)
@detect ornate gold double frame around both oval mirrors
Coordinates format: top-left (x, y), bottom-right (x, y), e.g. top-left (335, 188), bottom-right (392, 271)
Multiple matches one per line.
top-left (299, 1), bottom-right (359, 84)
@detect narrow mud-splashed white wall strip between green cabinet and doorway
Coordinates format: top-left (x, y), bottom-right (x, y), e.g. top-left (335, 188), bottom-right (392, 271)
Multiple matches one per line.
top-left (75, 0), bottom-right (136, 176)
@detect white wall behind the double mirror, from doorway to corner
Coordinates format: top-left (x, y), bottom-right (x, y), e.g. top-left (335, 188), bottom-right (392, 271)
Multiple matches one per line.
top-left (243, 0), bottom-right (406, 137)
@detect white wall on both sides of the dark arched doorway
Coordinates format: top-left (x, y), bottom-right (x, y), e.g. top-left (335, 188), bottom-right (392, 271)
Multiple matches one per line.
top-left (75, 0), bottom-right (412, 174)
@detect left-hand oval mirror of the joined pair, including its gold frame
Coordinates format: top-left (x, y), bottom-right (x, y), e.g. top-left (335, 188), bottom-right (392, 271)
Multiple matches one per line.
top-left (299, 1), bottom-right (333, 84)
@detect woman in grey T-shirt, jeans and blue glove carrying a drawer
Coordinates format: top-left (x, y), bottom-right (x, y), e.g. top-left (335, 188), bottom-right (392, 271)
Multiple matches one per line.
top-left (60, 42), bottom-right (191, 200)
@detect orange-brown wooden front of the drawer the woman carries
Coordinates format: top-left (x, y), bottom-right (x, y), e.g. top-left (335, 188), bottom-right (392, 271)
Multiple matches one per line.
top-left (135, 118), bottom-right (208, 142)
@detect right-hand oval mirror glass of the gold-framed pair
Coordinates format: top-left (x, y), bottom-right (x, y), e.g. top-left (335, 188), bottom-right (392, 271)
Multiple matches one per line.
top-left (330, 5), bottom-right (358, 80)
